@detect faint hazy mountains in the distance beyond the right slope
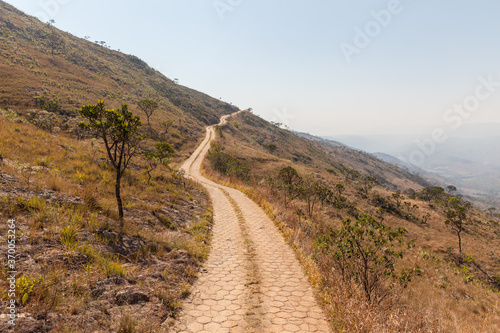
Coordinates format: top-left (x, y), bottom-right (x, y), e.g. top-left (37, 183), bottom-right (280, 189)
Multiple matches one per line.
top-left (326, 123), bottom-right (500, 205)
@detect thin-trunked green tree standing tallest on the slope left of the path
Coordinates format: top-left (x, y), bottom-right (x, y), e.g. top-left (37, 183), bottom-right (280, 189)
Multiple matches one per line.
top-left (80, 101), bottom-right (143, 228)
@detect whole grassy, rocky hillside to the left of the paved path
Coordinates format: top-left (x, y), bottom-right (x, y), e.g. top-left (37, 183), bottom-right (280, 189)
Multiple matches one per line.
top-left (0, 1), bottom-right (242, 332)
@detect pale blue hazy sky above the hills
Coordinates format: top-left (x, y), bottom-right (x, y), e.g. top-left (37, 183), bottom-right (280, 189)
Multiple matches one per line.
top-left (3, 0), bottom-right (500, 135)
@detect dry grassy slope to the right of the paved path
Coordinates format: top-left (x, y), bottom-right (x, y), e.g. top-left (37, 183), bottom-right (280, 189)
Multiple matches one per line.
top-left (205, 112), bottom-right (500, 332)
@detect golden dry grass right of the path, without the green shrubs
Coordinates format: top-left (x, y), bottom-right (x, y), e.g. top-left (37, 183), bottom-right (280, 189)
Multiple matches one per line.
top-left (204, 112), bottom-right (500, 332)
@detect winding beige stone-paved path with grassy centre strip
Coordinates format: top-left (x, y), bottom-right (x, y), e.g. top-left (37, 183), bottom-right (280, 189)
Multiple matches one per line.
top-left (174, 116), bottom-right (329, 333)
